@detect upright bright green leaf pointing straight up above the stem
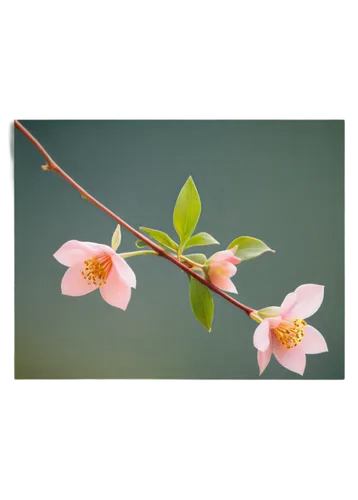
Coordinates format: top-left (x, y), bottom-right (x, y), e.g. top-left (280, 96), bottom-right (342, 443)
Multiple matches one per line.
top-left (173, 176), bottom-right (201, 248)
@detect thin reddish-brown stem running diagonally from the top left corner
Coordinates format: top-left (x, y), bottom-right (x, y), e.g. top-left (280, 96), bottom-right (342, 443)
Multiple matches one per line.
top-left (14, 118), bottom-right (254, 315)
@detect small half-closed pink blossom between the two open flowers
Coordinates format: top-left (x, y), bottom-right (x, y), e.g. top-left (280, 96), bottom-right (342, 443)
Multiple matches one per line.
top-left (206, 246), bottom-right (241, 293)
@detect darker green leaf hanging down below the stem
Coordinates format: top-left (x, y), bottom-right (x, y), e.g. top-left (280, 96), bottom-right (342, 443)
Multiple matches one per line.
top-left (189, 277), bottom-right (214, 332)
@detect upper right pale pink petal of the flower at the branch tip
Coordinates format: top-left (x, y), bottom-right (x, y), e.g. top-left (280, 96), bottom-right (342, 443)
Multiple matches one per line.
top-left (284, 285), bottom-right (324, 319)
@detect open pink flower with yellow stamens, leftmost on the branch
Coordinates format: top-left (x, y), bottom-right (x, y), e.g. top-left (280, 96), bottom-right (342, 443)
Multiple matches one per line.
top-left (54, 240), bottom-right (136, 311)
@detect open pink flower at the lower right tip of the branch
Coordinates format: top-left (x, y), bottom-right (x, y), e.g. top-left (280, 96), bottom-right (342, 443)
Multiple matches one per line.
top-left (254, 285), bottom-right (328, 375)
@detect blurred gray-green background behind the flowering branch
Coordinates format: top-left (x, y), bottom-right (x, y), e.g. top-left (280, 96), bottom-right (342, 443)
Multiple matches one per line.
top-left (14, 119), bottom-right (346, 381)
